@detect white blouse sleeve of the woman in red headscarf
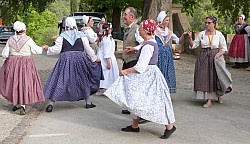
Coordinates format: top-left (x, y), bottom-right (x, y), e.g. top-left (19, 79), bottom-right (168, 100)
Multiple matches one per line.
top-left (134, 39), bottom-right (156, 73)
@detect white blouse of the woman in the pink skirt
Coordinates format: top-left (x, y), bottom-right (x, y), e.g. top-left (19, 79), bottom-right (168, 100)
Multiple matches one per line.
top-left (2, 38), bottom-right (43, 59)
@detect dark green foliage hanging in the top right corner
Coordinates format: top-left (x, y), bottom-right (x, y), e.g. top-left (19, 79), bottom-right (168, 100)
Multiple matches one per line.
top-left (211, 0), bottom-right (250, 23)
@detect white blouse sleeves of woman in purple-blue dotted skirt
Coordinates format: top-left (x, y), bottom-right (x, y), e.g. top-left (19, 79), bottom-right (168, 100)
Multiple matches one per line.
top-left (47, 36), bottom-right (97, 62)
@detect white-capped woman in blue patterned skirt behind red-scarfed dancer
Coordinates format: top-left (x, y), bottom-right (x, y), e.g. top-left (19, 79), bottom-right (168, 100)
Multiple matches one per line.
top-left (155, 11), bottom-right (183, 93)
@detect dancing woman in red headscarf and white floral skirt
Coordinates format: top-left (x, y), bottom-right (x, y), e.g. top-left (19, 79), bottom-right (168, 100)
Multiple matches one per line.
top-left (104, 19), bottom-right (176, 139)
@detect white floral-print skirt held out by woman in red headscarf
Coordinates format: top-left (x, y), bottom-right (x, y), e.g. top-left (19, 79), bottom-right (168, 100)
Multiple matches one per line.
top-left (104, 65), bottom-right (175, 125)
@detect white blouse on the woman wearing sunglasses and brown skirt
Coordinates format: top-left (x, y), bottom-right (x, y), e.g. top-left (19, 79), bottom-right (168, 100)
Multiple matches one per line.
top-left (191, 30), bottom-right (227, 51)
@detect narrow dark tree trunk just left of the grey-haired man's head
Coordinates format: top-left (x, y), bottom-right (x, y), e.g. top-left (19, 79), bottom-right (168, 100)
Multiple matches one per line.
top-left (112, 7), bottom-right (121, 32)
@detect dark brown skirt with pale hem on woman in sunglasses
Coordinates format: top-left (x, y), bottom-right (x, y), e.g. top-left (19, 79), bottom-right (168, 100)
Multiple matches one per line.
top-left (194, 49), bottom-right (220, 99)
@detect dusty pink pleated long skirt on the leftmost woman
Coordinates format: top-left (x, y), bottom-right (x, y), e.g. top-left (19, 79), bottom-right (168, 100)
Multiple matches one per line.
top-left (0, 56), bottom-right (45, 105)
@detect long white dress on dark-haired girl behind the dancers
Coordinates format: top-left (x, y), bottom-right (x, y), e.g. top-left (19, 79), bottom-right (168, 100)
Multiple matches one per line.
top-left (98, 35), bottom-right (119, 89)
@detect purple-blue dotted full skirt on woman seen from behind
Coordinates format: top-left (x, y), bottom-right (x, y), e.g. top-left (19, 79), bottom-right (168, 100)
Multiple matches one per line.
top-left (44, 51), bottom-right (103, 101)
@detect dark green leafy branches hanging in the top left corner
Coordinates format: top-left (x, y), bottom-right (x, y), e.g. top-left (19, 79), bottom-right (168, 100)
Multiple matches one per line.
top-left (0, 0), bottom-right (54, 24)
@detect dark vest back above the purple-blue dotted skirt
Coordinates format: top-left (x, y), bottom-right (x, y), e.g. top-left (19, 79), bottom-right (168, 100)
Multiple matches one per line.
top-left (61, 38), bottom-right (84, 52)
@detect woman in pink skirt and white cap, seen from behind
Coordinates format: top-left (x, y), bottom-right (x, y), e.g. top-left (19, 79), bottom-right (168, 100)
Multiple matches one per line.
top-left (0, 21), bottom-right (45, 115)
